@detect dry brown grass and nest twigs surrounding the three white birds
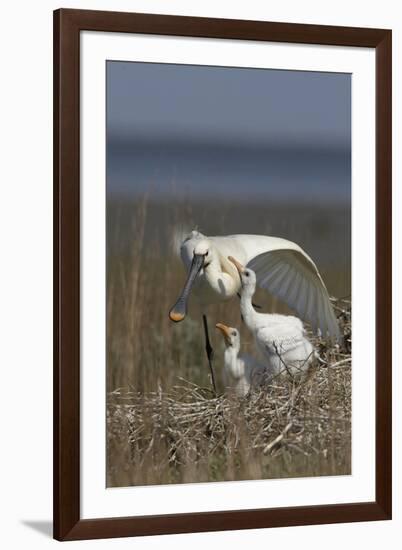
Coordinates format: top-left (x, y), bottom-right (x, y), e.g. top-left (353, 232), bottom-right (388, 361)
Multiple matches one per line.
top-left (106, 198), bottom-right (351, 487)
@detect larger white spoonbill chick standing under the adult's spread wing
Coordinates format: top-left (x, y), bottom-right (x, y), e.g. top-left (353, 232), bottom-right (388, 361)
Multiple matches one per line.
top-left (228, 257), bottom-right (315, 374)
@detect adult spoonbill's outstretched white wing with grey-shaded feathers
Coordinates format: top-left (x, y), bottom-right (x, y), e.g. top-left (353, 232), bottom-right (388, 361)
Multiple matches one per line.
top-left (214, 235), bottom-right (339, 339)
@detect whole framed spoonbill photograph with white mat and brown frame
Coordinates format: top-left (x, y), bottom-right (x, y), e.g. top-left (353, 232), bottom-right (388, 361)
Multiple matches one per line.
top-left (54, 9), bottom-right (392, 540)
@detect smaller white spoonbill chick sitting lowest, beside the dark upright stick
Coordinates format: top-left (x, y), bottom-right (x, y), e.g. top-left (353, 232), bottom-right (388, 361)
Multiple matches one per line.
top-left (215, 323), bottom-right (270, 397)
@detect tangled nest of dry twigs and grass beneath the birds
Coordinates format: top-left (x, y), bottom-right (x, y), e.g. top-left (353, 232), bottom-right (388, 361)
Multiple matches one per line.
top-left (107, 300), bottom-right (351, 486)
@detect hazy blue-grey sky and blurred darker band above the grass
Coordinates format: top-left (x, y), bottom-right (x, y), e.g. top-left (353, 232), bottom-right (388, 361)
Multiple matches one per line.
top-left (107, 61), bottom-right (351, 201)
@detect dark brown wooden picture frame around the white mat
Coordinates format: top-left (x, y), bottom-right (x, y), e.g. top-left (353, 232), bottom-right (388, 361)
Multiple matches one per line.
top-left (53, 9), bottom-right (392, 540)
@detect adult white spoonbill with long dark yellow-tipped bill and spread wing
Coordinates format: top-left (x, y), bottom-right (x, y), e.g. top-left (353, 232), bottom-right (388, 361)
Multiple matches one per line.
top-left (170, 231), bottom-right (339, 339)
